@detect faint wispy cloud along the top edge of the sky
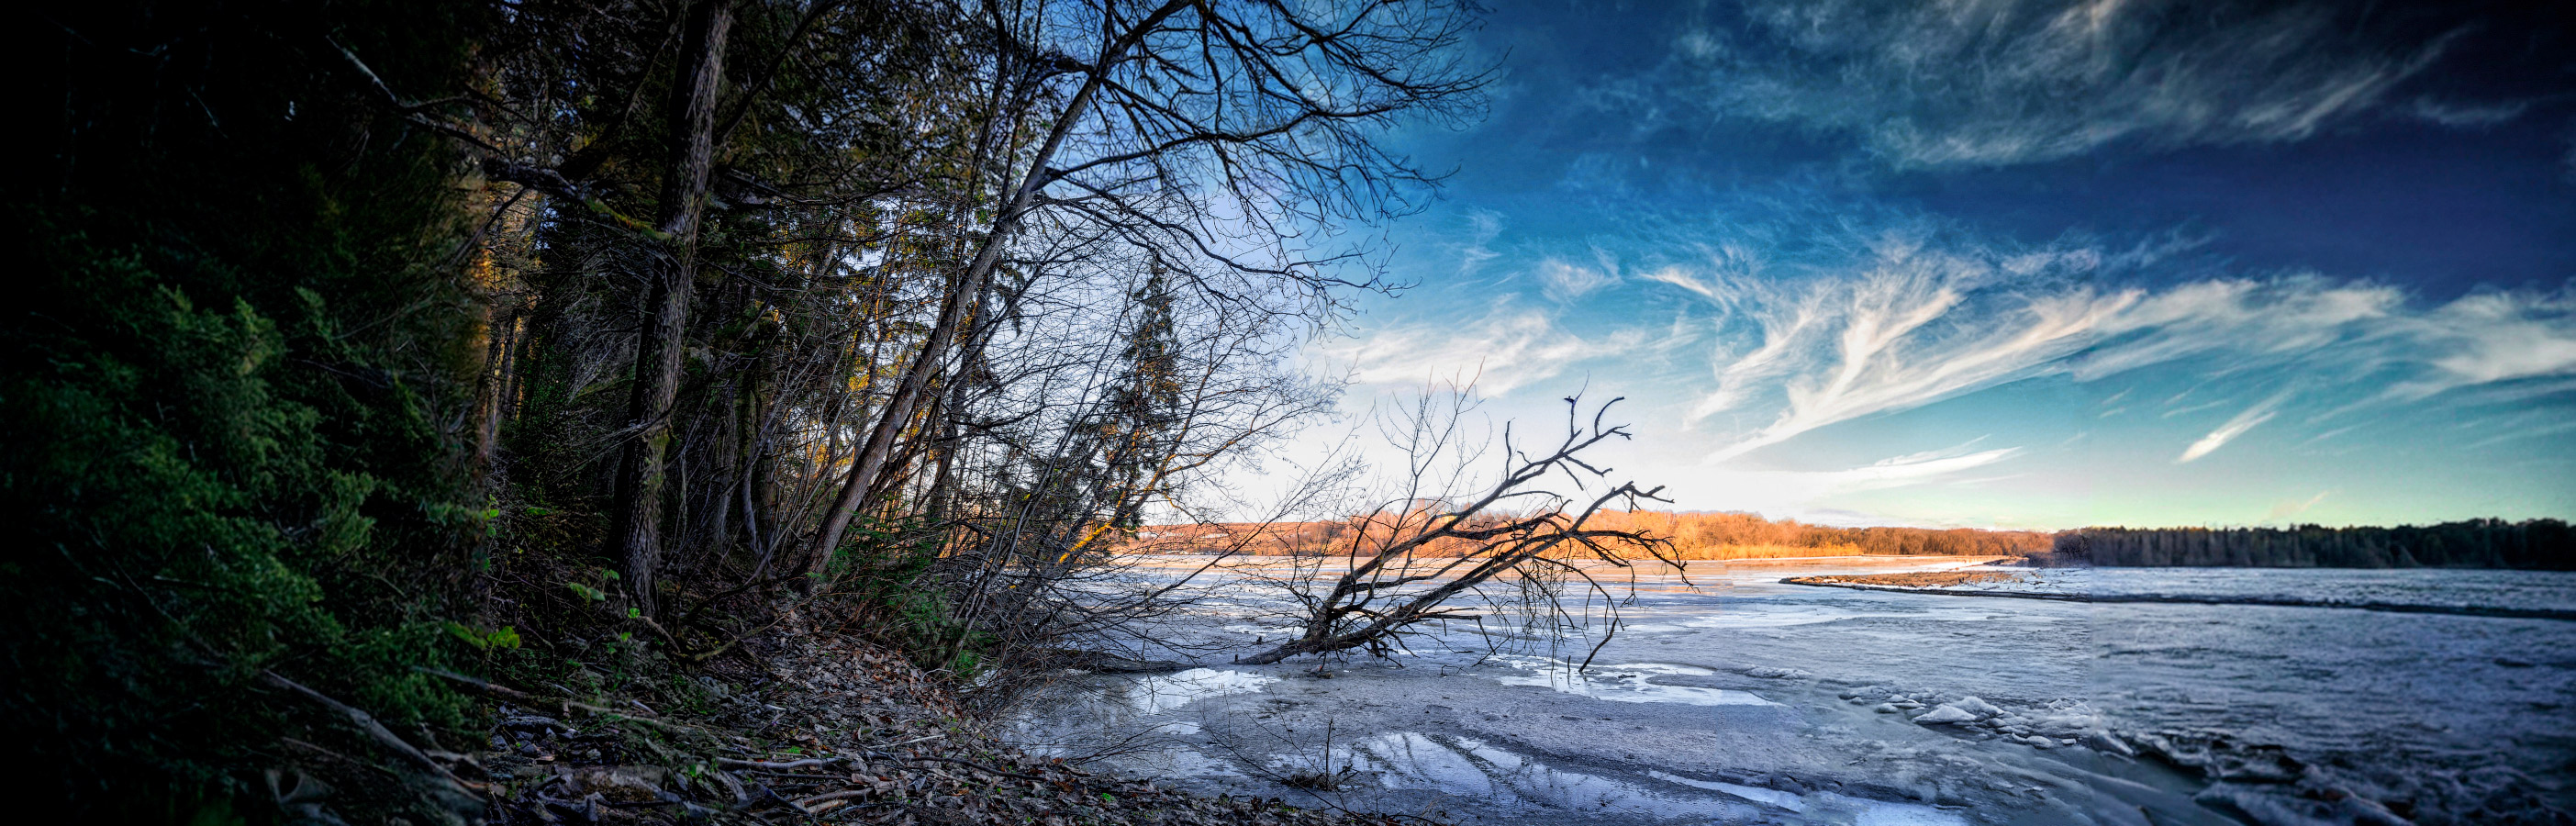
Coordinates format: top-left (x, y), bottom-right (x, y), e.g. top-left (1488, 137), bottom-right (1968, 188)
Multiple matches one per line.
top-left (1677, 0), bottom-right (2462, 167)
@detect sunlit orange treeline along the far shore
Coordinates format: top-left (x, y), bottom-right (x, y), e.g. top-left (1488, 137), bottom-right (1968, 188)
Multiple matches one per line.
top-left (1133, 509), bottom-right (2050, 558)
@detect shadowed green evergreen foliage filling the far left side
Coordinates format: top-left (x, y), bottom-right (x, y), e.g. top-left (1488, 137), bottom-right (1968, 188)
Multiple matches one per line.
top-left (0, 3), bottom-right (497, 820)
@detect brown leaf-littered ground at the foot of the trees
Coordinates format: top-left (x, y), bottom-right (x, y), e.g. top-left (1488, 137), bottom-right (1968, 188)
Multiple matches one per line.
top-left (451, 604), bottom-right (1386, 826)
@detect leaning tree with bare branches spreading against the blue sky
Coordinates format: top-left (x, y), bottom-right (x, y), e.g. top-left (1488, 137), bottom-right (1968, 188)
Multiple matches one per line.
top-left (807, 0), bottom-right (1489, 574)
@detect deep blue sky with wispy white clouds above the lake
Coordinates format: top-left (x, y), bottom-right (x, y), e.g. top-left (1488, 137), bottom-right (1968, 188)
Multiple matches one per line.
top-left (1306, 0), bottom-right (2576, 530)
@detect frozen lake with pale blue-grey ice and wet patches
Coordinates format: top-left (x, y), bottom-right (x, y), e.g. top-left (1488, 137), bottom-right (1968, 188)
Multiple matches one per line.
top-left (1012, 558), bottom-right (2576, 823)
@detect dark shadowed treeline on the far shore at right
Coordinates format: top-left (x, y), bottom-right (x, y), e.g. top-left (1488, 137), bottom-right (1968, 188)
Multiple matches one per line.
top-left (2053, 519), bottom-right (2576, 571)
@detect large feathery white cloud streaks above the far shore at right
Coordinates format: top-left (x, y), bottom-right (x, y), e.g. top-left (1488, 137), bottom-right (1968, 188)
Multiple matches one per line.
top-left (1646, 217), bottom-right (2576, 463)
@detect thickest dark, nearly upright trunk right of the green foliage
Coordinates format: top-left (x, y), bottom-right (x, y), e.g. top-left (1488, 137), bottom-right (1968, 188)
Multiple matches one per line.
top-left (610, 0), bottom-right (734, 615)
